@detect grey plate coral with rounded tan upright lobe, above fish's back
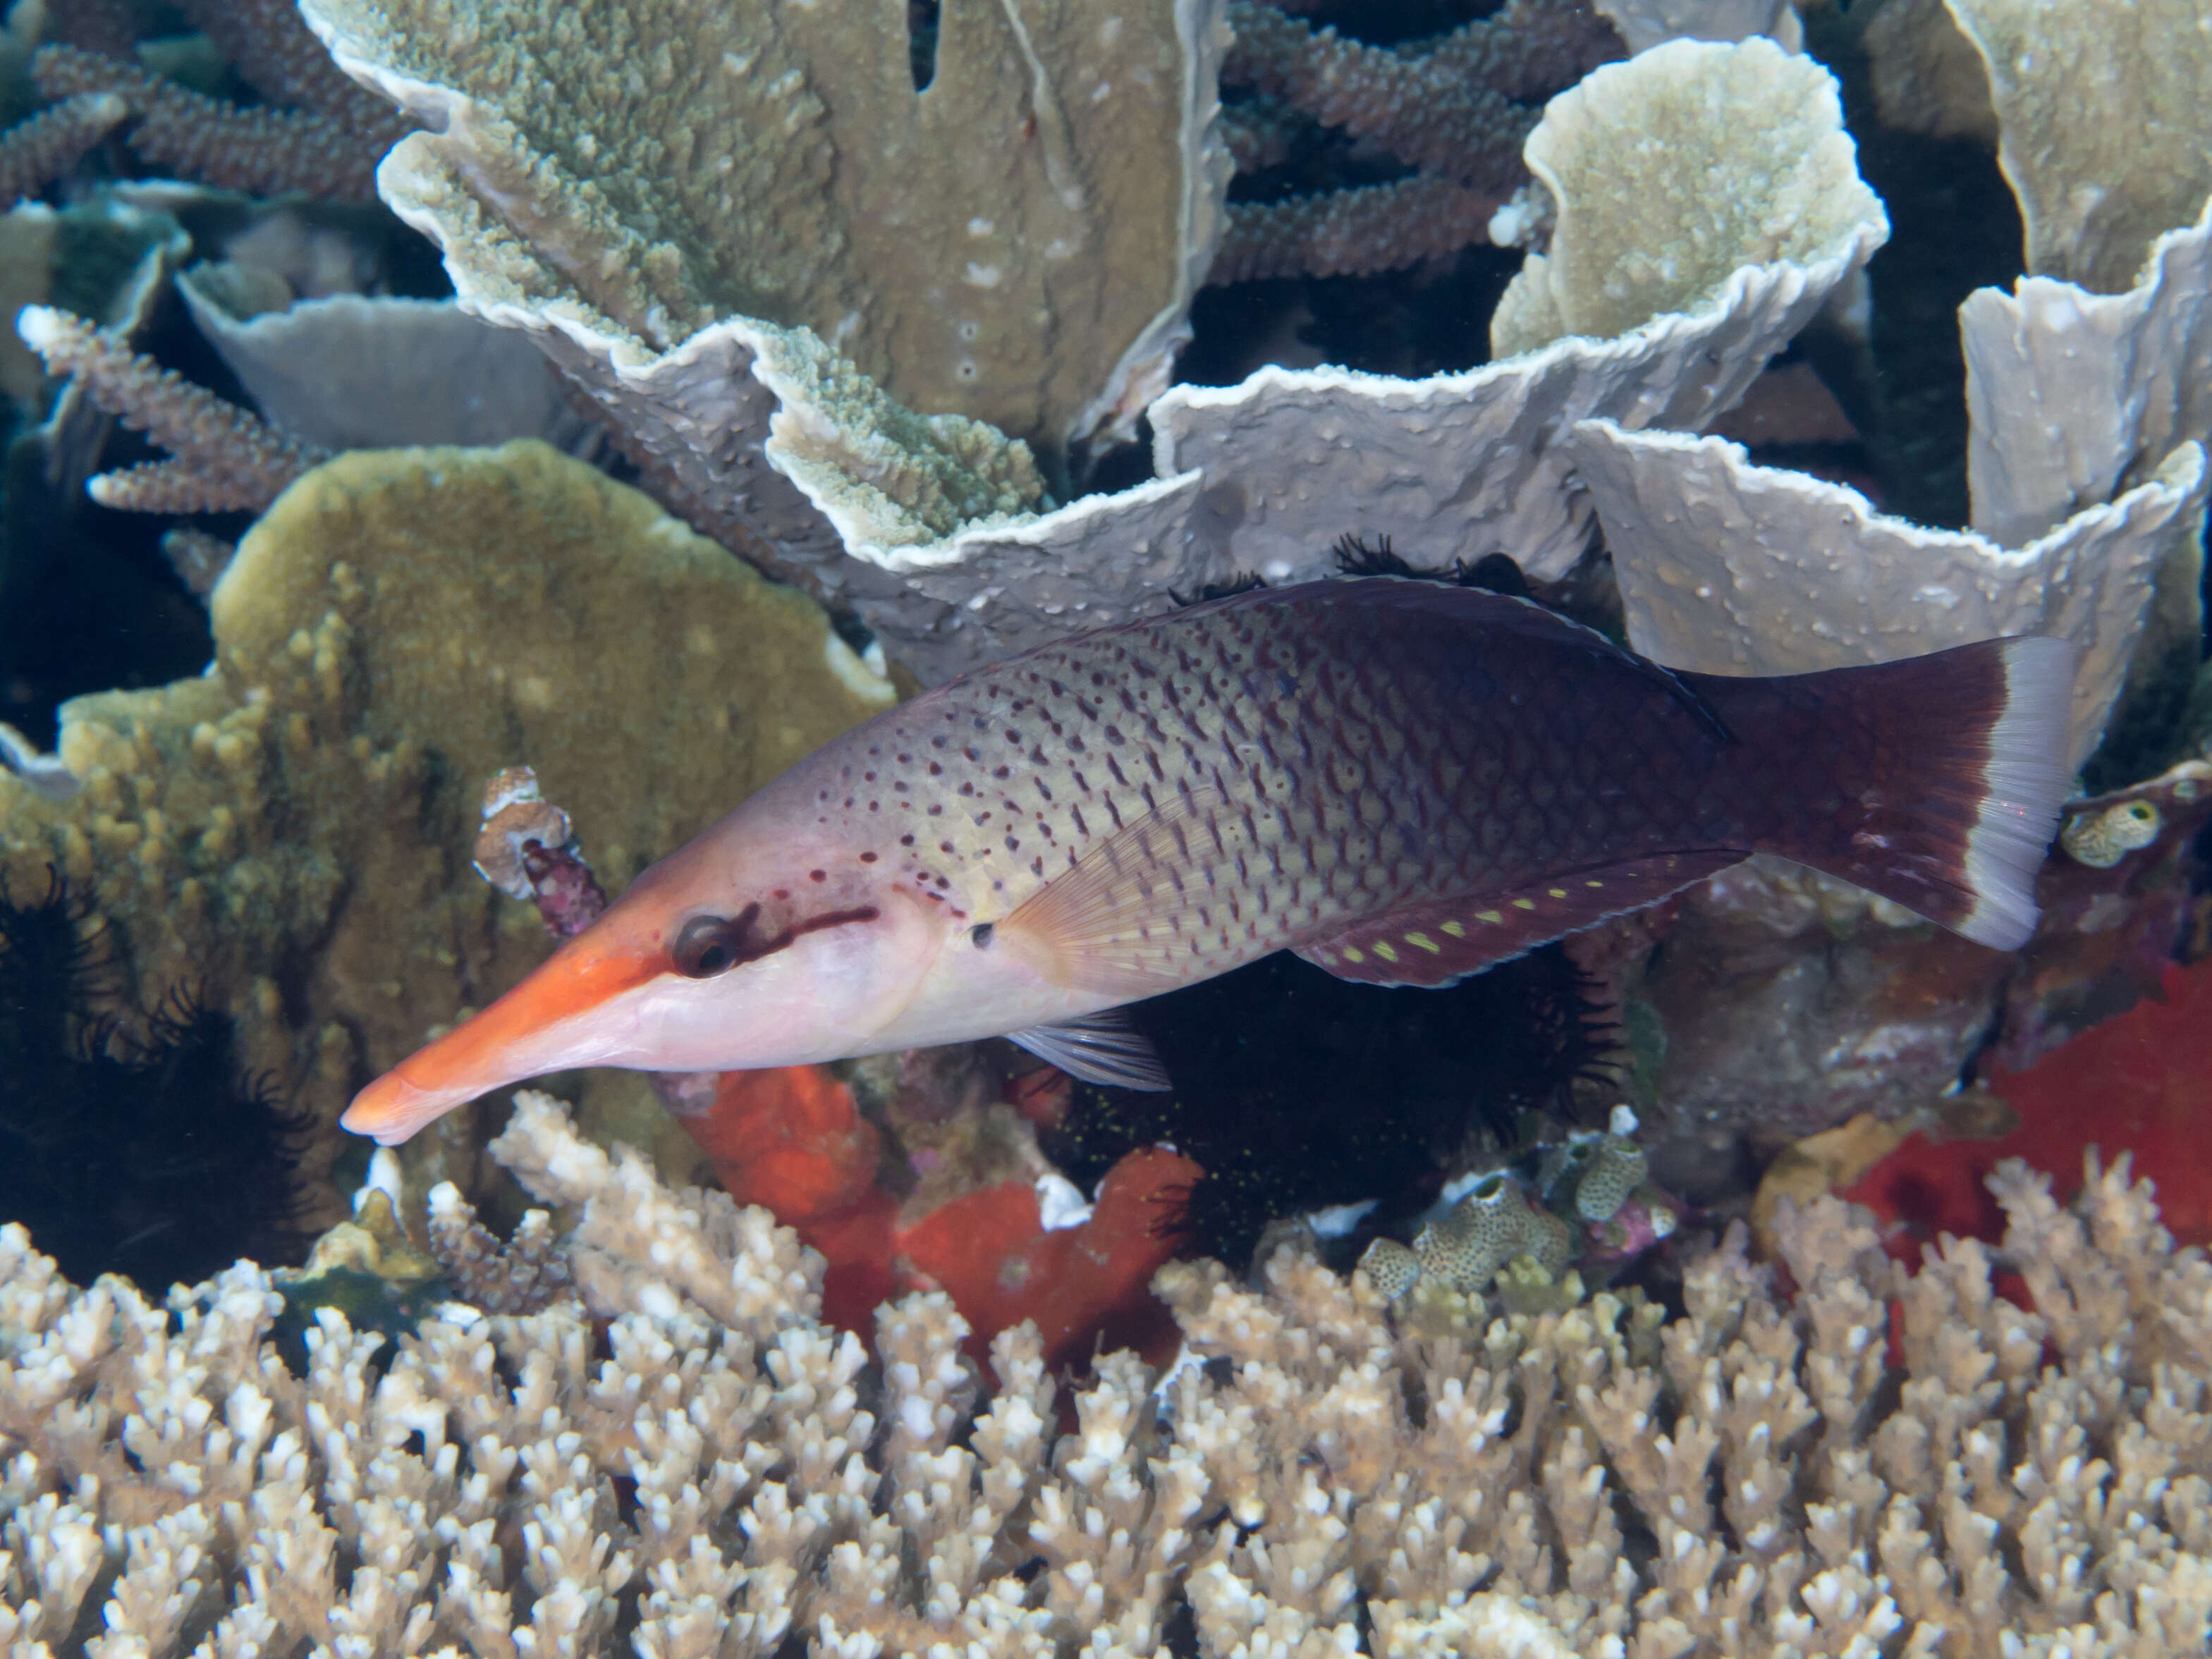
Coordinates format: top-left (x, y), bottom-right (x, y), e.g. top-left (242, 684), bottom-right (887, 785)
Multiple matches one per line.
top-left (1152, 39), bottom-right (1887, 586)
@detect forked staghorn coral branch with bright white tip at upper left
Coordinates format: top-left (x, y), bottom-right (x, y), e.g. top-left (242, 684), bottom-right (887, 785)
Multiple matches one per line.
top-left (16, 305), bottom-right (329, 513)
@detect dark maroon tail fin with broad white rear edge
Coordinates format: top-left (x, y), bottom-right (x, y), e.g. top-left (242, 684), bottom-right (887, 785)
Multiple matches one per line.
top-left (1683, 637), bottom-right (2075, 951)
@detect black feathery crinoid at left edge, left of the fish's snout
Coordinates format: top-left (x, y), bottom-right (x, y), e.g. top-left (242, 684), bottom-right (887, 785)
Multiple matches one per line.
top-left (0, 871), bottom-right (305, 1290)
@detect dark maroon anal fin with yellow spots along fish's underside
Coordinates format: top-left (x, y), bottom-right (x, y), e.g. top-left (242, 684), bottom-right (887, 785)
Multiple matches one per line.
top-left (1298, 852), bottom-right (1745, 986)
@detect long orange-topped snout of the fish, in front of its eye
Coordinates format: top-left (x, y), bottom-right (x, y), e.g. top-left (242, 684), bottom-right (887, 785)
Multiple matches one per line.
top-left (338, 929), bottom-right (659, 1146)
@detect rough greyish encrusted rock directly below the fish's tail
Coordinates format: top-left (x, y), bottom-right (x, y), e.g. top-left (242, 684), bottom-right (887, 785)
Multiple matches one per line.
top-left (1568, 761), bottom-right (2212, 1196)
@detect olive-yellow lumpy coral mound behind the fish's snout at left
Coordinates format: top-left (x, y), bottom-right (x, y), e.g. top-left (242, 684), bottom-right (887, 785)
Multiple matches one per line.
top-left (0, 442), bottom-right (893, 1221)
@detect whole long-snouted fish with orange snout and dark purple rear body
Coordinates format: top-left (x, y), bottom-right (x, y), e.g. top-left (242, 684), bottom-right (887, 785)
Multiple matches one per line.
top-left (345, 577), bottom-right (2075, 1144)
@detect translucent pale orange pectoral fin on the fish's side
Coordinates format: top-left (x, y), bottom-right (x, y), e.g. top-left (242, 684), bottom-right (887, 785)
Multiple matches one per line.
top-left (994, 788), bottom-right (1241, 1002)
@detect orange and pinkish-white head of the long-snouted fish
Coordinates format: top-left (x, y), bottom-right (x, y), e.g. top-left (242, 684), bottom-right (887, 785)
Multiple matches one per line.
top-left (343, 821), bottom-right (947, 1146)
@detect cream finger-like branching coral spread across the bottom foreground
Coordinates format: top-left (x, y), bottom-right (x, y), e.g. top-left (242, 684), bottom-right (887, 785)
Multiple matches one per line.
top-left (0, 1097), bottom-right (2212, 1659)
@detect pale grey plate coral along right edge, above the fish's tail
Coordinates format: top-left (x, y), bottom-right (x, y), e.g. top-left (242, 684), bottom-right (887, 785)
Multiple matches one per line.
top-left (1570, 0), bottom-right (2212, 780)
